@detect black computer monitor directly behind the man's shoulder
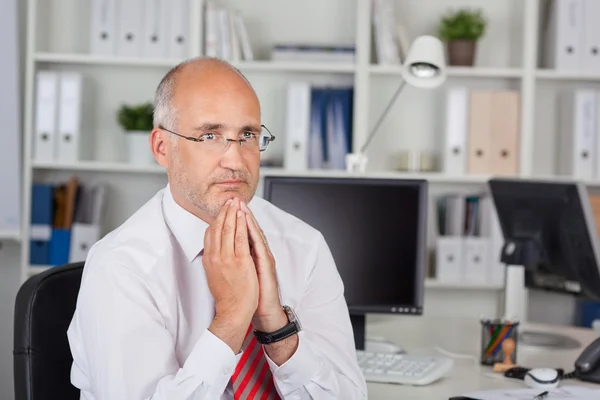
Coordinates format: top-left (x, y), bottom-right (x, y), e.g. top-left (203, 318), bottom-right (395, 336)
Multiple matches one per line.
top-left (264, 176), bottom-right (427, 350)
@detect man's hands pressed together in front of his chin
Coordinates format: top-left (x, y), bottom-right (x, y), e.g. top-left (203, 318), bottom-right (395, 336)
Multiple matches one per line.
top-left (202, 199), bottom-right (287, 353)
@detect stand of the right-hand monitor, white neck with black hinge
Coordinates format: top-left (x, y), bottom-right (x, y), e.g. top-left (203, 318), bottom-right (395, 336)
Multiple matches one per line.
top-left (501, 238), bottom-right (581, 349)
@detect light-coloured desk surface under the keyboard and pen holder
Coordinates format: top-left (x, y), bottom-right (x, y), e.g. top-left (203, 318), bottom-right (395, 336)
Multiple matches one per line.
top-left (366, 315), bottom-right (600, 400)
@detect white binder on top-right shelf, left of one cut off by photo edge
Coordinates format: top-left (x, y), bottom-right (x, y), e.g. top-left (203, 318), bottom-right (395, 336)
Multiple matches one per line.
top-left (544, 0), bottom-right (594, 71)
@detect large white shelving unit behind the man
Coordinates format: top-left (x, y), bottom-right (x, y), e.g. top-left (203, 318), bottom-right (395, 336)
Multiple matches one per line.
top-left (11, 0), bottom-right (600, 318)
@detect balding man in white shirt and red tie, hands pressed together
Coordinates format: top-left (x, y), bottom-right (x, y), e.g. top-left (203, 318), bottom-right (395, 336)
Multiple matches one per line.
top-left (68, 58), bottom-right (367, 400)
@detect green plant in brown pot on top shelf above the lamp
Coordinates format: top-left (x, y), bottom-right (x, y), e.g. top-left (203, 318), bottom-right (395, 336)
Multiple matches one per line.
top-left (438, 8), bottom-right (487, 66)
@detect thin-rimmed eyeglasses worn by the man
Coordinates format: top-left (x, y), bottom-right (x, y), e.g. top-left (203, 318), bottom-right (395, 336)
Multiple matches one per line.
top-left (158, 125), bottom-right (275, 153)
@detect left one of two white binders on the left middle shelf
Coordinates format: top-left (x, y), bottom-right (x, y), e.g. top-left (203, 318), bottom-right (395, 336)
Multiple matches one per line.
top-left (33, 71), bottom-right (58, 162)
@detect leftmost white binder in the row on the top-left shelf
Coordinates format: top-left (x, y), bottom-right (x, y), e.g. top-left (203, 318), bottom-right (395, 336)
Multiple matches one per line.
top-left (90, 0), bottom-right (117, 56)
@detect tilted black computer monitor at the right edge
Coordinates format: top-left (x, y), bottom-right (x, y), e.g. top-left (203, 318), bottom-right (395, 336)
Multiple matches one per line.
top-left (489, 178), bottom-right (600, 299)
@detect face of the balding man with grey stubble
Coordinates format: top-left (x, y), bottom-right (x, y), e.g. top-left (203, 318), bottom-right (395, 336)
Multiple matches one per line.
top-left (165, 69), bottom-right (261, 217)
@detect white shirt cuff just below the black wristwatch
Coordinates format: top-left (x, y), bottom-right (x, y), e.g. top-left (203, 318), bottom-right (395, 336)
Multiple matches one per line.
top-left (265, 332), bottom-right (321, 395)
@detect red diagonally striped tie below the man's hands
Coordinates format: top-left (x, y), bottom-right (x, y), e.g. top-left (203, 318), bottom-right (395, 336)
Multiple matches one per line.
top-left (231, 326), bottom-right (280, 400)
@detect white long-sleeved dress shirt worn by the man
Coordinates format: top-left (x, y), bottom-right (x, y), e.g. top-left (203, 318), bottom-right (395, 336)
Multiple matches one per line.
top-left (68, 186), bottom-right (367, 400)
